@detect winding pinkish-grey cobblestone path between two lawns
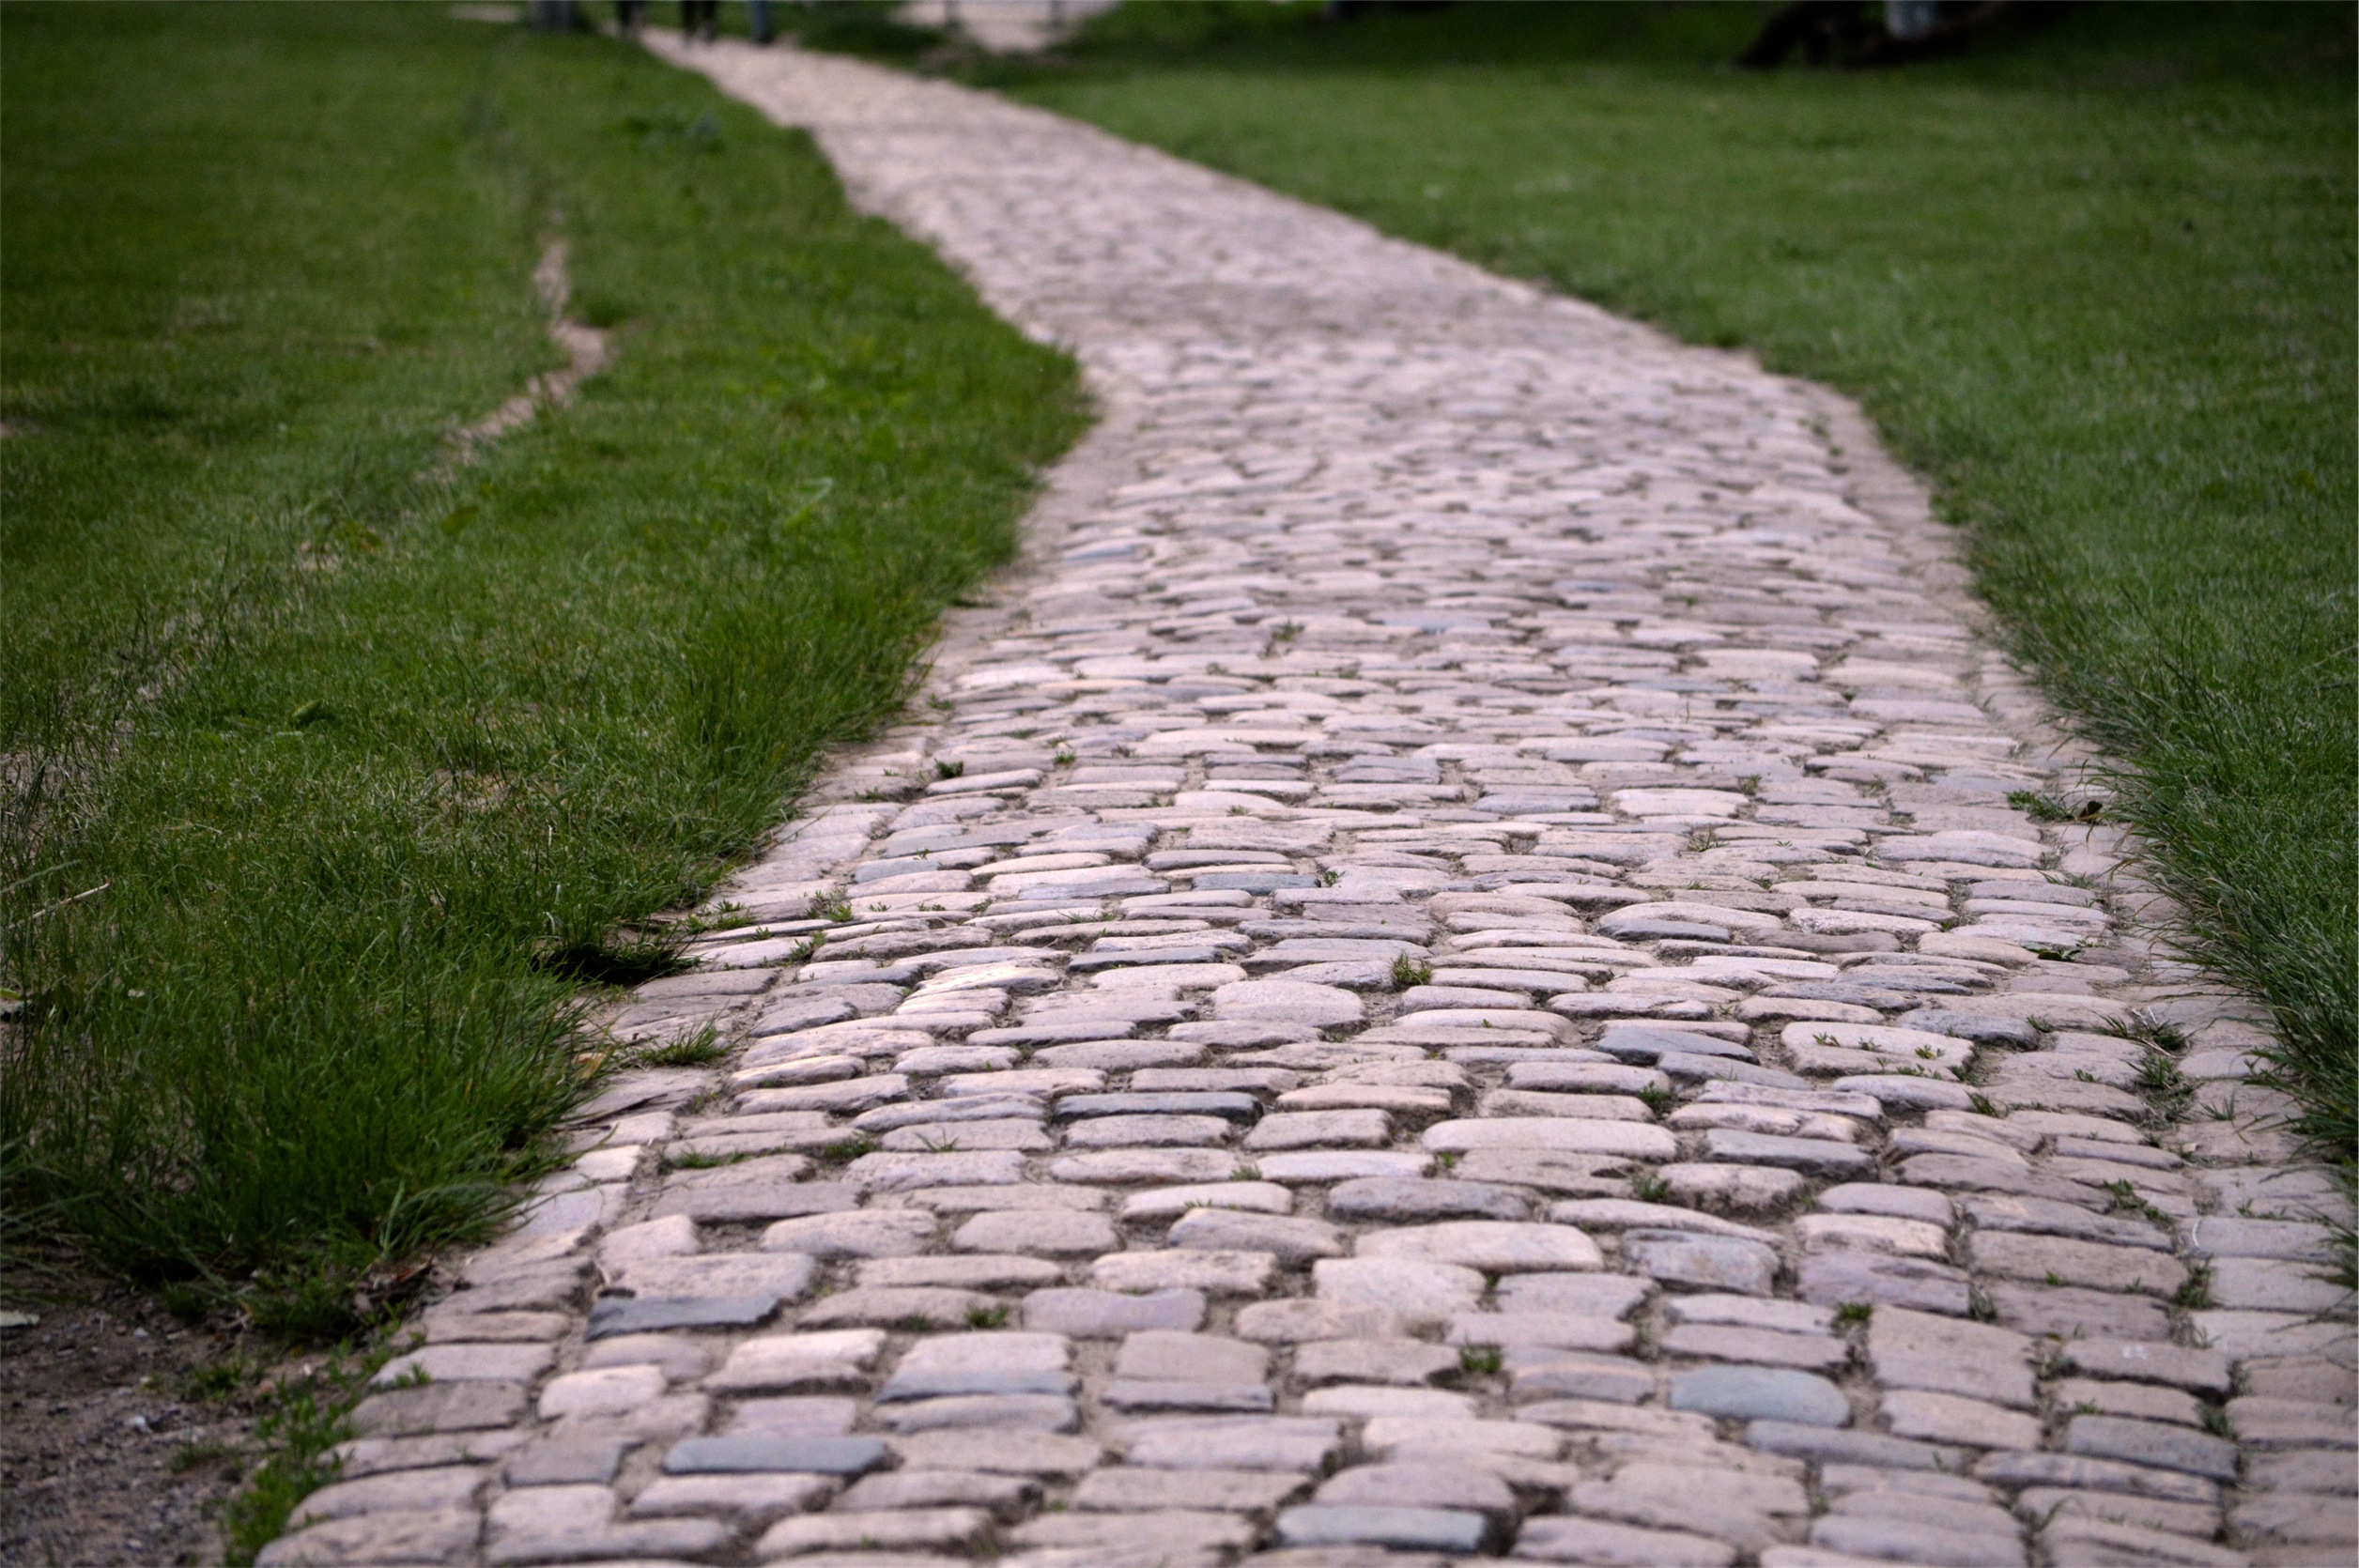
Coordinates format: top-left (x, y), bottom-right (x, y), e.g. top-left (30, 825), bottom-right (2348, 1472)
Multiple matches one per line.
top-left (264, 42), bottom-right (2354, 1568)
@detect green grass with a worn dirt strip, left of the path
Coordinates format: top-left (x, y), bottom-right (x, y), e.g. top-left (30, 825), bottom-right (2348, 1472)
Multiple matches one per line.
top-left (0, 5), bottom-right (1083, 1334)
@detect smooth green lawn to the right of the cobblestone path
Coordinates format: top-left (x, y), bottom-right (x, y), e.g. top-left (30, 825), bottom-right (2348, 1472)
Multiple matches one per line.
top-left (887, 5), bottom-right (2359, 1161)
